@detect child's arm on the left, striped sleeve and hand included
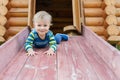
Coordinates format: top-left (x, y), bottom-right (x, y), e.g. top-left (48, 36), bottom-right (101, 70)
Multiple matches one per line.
top-left (25, 32), bottom-right (36, 56)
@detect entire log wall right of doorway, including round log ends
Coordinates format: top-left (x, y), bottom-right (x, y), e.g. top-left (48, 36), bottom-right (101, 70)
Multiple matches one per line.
top-left (84, 0), bottom-right (120, 42)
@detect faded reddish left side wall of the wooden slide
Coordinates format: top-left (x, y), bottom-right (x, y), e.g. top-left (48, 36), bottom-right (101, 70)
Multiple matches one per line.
top-left (0, 28), bottom-right (29, 72)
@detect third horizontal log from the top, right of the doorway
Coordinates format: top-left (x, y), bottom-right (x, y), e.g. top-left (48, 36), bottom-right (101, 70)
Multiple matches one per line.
top-left (85, 17), bottom-right (104, 26)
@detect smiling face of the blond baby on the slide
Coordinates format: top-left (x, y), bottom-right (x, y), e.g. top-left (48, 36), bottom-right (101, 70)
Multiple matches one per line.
top-left (34, 21), bottom-right (50, 36)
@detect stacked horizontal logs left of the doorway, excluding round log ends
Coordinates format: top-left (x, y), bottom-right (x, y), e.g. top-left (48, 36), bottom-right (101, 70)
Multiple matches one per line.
top-left (4, 0), bottom-right (29, 40)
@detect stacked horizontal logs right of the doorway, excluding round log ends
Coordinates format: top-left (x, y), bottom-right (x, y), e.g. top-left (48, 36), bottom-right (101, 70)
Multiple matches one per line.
top-left (83, 0), bottom-right (108, 40)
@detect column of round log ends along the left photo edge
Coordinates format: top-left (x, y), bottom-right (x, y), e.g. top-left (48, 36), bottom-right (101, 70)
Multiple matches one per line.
top-left (0, 0), bottom-right (8, 44)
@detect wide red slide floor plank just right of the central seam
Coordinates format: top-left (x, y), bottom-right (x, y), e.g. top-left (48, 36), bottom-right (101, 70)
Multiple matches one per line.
top-left (57, 37), bottom-right (99, 80)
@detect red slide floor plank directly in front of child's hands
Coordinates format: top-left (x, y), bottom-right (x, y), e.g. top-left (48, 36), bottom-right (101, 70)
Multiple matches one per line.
top-left (17, 49), bottom-right (56, 80)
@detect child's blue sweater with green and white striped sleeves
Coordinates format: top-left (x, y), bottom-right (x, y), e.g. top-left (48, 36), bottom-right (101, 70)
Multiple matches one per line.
top-left (24, 29), bottom-right (57, 51)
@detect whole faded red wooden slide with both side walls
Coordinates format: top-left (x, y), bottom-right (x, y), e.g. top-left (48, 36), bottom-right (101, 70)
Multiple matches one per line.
top-left (0, 27), bottom-right (120, 80)
